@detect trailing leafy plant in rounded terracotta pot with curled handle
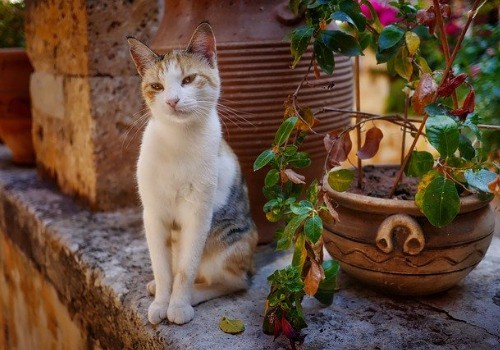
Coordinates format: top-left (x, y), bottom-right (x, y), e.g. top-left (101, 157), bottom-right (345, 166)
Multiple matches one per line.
top-left (254, 0), bottom-right (500, 347)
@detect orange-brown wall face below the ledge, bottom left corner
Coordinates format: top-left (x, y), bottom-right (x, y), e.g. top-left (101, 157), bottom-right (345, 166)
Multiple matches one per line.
top-left (0, 233), bottom-right (88, 349)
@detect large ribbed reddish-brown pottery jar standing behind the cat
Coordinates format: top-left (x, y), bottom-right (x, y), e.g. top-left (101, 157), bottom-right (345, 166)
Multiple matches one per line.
top-left (153, 0), bottom-right (353, 243)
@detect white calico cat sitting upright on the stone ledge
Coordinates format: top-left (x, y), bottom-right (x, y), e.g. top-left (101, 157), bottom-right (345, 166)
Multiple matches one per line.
top-left (127, 22), bottom-right (257, 324)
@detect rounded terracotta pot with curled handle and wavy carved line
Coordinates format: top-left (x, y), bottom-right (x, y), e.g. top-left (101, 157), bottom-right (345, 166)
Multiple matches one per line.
top-left (323, 179), bottom-right (495, 295)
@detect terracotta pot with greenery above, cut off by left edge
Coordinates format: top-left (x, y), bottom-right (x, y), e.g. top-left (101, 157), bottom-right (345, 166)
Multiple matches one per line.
top-left (0, 1), bottom-right (35, 165)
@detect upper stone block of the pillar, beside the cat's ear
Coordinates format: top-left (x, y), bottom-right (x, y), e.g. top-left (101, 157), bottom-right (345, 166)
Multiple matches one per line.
top-left (25, 0), bottom-right (158, 76)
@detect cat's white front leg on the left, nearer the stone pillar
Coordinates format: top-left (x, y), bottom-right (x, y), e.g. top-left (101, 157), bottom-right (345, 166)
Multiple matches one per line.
top-left (143, 210), bottom-right (172, 324)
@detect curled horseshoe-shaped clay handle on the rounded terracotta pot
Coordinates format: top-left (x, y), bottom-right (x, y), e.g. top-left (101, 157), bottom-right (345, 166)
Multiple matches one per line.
top-left (375, 214), bottom-right (425, 255)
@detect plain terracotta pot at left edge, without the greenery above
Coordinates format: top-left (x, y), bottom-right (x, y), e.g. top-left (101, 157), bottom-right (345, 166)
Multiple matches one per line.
top-left (0, 48), bottom-right (35, 165)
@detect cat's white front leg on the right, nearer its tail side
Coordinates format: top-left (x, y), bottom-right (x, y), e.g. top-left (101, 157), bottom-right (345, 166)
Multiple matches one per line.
top-left (167, 196), bottom-right (212, 324)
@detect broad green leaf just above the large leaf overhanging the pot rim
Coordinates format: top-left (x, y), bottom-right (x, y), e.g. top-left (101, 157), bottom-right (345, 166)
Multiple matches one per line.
top-left (425, 115), bottom-right (460, 158)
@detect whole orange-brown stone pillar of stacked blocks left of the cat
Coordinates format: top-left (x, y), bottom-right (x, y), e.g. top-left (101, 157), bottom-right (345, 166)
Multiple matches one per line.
top-left (26, 0), bottom-right (159, 210)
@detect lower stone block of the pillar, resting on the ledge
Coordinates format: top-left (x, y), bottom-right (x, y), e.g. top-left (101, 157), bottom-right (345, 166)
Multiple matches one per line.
top-left (33, 73), bottom-right (145, 210)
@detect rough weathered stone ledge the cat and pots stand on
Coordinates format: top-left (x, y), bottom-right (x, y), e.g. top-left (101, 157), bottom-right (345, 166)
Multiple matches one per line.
top-left (0, 147), bottom-right (500, 349)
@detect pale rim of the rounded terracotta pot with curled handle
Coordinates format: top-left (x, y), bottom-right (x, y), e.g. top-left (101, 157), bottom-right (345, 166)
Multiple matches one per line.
top-left (328, 189), bottom-right (492, 216)
